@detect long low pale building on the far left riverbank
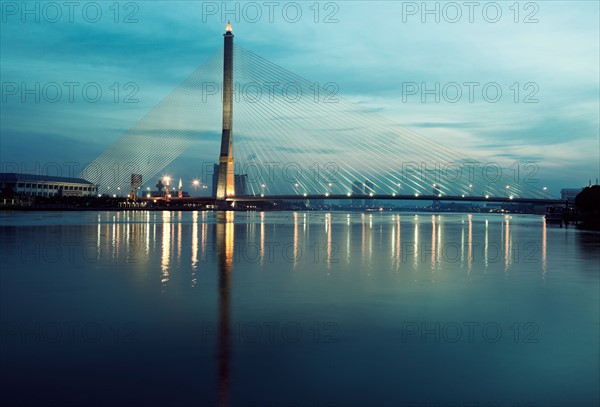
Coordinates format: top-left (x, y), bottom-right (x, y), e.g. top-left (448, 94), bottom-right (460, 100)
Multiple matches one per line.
top-left (0, 172), bottom-right (98, 197)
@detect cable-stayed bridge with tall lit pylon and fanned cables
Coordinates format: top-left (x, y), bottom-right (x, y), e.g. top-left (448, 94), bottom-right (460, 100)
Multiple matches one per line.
top-left (80, 25), bottom-right (558, 203)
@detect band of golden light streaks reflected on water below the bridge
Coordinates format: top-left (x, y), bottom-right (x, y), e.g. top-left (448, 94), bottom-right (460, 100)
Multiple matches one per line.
top-left (94, 211), bottom-right (564, 289)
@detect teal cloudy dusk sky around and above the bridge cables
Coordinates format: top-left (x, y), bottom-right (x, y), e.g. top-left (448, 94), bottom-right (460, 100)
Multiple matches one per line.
top-left (0, 1), bottom-right (600, 195)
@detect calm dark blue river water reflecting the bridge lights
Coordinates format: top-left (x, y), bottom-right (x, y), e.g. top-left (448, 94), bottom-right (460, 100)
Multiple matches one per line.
top-left (0, 212), bottom-right (600, 407)
